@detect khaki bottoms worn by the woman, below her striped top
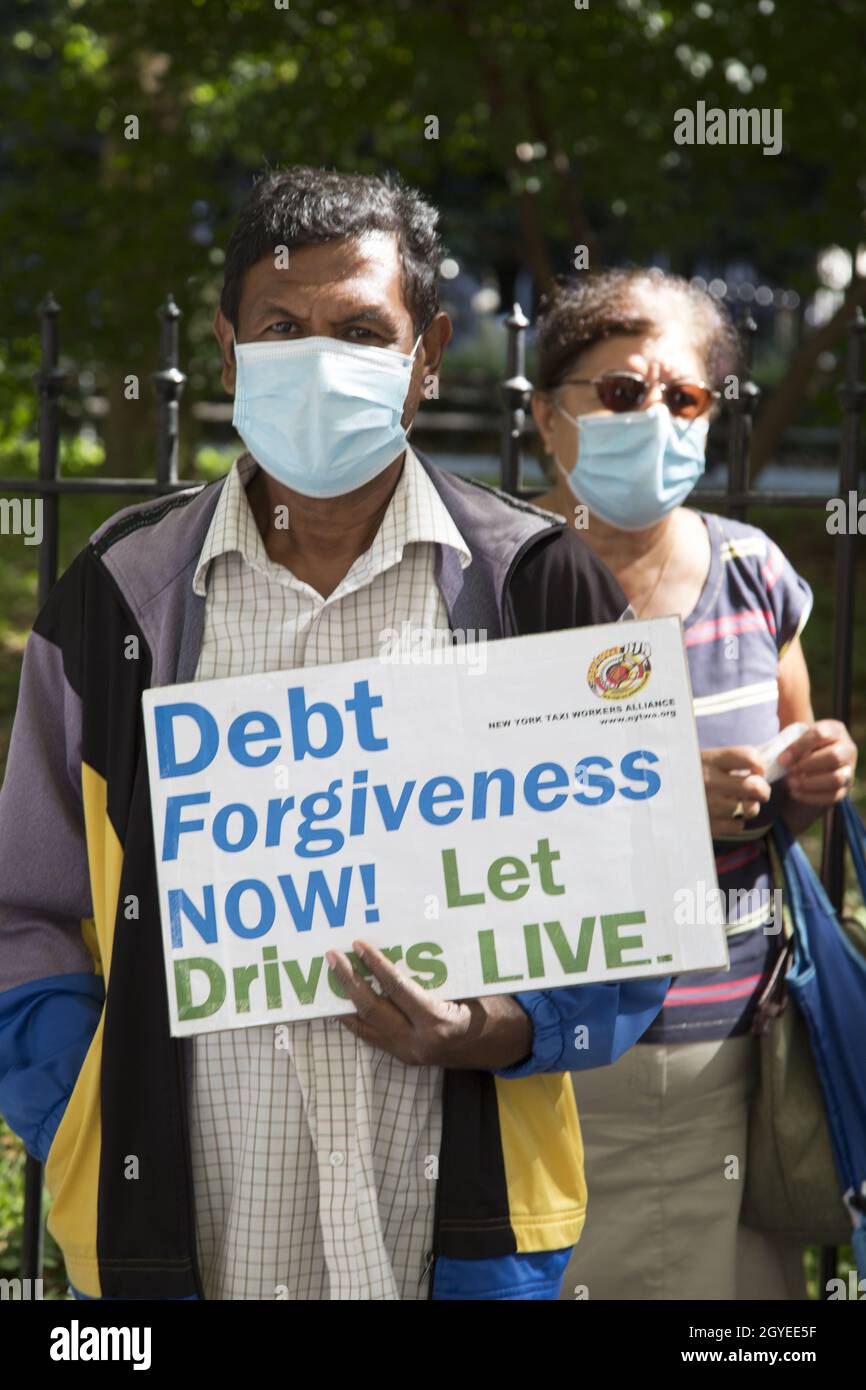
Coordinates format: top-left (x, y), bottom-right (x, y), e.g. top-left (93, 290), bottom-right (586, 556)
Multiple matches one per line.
top-left (560, 1036), bottom-right (808, 1300)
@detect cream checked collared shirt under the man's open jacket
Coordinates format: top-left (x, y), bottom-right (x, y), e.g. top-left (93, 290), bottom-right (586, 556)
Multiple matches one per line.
top-left (190, 448), bottom-right (471, 1300)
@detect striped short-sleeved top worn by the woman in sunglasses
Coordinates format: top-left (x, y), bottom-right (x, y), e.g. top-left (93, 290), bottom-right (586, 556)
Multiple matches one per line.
top-left (641, 512), bottom-right (812, 1043)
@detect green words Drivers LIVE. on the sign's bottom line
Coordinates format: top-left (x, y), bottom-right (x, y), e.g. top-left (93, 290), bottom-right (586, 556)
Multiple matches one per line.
top-left (174, 912), bottom-right (653, 1023)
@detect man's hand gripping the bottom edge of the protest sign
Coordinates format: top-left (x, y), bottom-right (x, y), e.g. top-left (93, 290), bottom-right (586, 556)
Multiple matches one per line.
top-left (325, 941), bottom-right (532, 1072)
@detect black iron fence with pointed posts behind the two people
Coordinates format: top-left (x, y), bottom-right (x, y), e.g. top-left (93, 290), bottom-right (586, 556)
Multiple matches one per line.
top-left (0, 295), bottom-right (866, 1287)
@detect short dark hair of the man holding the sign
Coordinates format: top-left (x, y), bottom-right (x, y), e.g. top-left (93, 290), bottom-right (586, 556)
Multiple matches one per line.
top-left (220, 164), bottom-right (442, 334)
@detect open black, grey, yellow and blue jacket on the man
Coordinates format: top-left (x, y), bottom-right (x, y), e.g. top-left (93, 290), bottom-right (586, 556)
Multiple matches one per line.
top-left (0, 459), bottom-right (669, 1298)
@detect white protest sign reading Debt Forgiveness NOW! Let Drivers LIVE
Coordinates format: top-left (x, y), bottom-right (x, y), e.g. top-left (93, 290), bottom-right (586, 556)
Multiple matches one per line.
top-left (143, 619), bottom-right (727, 1036)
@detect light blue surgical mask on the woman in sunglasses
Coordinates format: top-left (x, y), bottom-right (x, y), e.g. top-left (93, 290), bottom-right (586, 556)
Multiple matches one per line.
top-left (556, 403), bottom-right (709, 531)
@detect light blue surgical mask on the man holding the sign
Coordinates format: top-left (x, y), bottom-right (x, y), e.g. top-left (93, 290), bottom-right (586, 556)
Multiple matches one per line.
top-left (232, 334), bottom-right (421, 498)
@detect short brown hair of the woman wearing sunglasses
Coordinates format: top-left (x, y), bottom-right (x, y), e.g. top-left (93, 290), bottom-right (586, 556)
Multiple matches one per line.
top-left (537, 268), bottom-right (741, 391)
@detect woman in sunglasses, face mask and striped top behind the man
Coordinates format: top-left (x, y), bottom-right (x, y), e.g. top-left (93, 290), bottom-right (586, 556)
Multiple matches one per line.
top-left (532, 270), bottom-right (856, 1300)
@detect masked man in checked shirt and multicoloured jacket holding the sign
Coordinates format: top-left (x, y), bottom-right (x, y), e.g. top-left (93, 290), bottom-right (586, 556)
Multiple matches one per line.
top-left (0, 168), bottom-right (666, 1300)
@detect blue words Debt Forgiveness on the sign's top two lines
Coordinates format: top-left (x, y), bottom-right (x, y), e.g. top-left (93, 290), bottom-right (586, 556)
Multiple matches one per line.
top-left (154, 680), bottom-right (662, 863)
